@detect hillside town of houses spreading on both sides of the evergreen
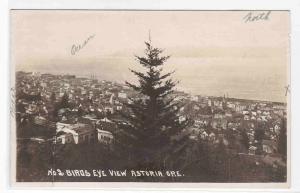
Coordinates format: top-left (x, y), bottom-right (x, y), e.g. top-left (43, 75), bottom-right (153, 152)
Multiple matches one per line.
top-left (15, 71), bottom-right (287, 181)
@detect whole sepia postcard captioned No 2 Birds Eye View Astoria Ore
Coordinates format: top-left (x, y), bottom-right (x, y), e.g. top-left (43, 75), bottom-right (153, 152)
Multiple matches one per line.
top-left (11, 10), bottom-right (290, 183)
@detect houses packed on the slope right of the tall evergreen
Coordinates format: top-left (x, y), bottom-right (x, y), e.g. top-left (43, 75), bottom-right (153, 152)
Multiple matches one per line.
top-left (180, 93), bottom-right (286, 155)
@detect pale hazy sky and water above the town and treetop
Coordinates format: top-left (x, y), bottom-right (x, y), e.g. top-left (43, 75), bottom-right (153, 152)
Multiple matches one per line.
top-left (11, 10), bottom-right (290, 102)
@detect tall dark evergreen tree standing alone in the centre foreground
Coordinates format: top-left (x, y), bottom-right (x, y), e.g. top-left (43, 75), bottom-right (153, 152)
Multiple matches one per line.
top-left (116, 40), bottom-right (188, 169)
